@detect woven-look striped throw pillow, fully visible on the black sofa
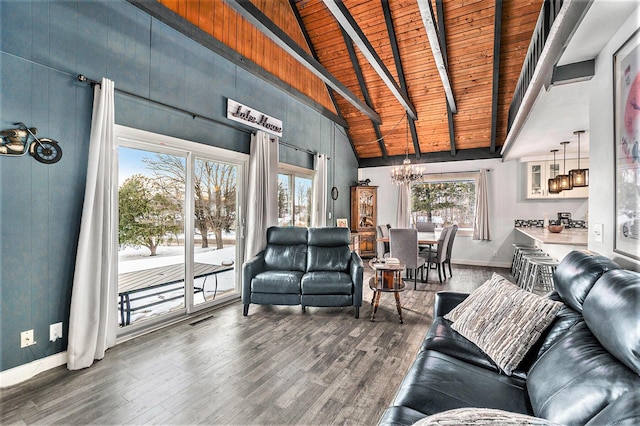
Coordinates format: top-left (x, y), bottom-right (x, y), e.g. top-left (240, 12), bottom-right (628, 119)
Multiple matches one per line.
top-left (444, 273), bottom-right (563, 375)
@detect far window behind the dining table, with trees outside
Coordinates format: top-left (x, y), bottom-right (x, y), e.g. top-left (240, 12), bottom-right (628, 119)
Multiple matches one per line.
top-left (411, 174), bottom-right (476, 231)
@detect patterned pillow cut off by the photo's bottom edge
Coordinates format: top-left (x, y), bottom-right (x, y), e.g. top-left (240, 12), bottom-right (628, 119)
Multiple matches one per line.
top-left (413, 408), bottom-right (556, 426)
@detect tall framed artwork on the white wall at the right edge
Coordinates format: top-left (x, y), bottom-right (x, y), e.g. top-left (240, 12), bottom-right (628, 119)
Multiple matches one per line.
top-left (613, 31), bottom-right (640, 259)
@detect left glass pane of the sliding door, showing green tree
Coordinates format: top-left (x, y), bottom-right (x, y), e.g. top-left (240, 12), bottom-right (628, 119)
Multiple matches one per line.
top-left (118, 147), bottom-right (187, 326)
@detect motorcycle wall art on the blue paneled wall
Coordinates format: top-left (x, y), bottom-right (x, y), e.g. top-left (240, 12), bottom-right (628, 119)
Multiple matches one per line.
top-left (0, 122), bottom-right (62, 164)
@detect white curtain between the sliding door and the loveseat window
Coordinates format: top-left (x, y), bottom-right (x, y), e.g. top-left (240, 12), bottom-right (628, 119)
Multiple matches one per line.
top-left (245, 131), bottom-right (278, 259)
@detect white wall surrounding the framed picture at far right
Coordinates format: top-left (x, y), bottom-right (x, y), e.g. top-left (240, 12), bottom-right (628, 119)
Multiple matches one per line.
top-left (589, 7), bottom-right (640, 270)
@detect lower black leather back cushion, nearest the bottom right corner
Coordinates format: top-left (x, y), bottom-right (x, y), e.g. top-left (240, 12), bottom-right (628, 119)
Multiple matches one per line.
top-left (527, 322), bottom-right (640, 425)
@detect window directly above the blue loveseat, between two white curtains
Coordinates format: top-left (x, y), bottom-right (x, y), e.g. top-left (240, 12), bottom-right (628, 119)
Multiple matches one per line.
top-left (278, 165), bottom-right (313, 226)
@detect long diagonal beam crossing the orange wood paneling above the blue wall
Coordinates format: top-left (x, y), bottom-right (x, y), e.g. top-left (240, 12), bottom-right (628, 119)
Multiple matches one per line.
top-left (225, 0), bottom-right (382, 124)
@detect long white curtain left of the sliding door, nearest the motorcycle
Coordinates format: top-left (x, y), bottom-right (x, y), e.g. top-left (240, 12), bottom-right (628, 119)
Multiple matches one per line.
top-left (67, 78), bottom-right (118, 370)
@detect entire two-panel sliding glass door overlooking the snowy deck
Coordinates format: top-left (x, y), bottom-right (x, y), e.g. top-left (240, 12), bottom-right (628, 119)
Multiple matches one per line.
top-left (117, 128), bottom-right (243, 333)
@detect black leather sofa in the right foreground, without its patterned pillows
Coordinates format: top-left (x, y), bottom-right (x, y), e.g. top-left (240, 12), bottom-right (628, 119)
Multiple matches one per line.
top-left (379, 251), bottom-right (640, 426)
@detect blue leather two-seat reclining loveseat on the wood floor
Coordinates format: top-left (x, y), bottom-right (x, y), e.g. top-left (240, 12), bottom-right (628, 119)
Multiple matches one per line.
top-left (242, 226), bottom-right (363, 318)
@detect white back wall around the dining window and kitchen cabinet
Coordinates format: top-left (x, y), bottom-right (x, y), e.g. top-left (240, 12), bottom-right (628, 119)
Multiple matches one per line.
top-left (358, 159), bottom-right (587, 267)
